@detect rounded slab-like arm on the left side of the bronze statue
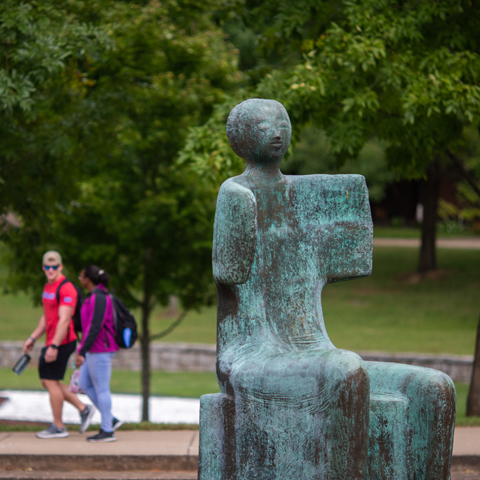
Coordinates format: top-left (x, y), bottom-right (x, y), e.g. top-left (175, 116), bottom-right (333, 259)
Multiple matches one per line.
top-left (212, 179), bottom-right (257, 285)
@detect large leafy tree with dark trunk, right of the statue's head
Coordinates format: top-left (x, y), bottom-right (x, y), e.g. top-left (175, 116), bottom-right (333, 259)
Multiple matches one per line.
top-left (184, 0), bottom-right (480, 272)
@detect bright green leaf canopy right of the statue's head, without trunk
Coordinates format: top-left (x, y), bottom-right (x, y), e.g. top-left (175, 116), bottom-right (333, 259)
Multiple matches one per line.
top-left (249, 0), bottom-right (480, 177)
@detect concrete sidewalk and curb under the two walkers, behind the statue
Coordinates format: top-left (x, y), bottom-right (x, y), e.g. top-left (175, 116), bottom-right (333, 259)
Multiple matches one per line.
top-left (0, 427), bottom-right (480, 474)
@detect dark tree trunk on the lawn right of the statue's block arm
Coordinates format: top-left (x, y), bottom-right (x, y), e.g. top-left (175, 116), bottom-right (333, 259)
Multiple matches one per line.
top-left (418, 160), bottom-right (440, 273)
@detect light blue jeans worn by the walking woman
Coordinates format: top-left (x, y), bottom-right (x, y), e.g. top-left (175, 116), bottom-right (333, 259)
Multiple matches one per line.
top-left (80, 352), bottom-right (115, 432)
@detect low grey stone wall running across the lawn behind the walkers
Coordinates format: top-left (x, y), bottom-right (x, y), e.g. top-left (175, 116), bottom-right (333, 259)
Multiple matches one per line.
top-left (0, 342), bottom-right (473, 383)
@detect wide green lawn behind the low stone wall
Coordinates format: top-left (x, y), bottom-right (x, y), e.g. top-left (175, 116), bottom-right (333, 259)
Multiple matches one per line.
top-left (0, 247), bottom-right (480, 355)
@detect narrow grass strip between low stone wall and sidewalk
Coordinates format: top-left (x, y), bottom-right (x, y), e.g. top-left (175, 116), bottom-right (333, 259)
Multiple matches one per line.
top-left (0, 368), bottom-right (480, 431)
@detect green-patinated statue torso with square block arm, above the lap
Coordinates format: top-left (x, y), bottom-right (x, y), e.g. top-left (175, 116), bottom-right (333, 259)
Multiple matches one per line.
top-left (214, 175), bottom-right (372, 374)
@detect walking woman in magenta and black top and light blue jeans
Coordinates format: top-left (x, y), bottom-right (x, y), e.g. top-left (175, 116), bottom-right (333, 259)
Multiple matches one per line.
top-left (75, 265), bottom-right (122, 442)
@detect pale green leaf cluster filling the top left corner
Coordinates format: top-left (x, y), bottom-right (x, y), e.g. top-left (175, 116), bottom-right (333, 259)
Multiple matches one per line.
top-left (0, 0), bottom-right (110, 114)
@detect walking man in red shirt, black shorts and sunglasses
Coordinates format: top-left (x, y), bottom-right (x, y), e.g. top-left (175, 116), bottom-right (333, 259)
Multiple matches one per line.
top-left (23, 251), bottom-right (94, 438)
